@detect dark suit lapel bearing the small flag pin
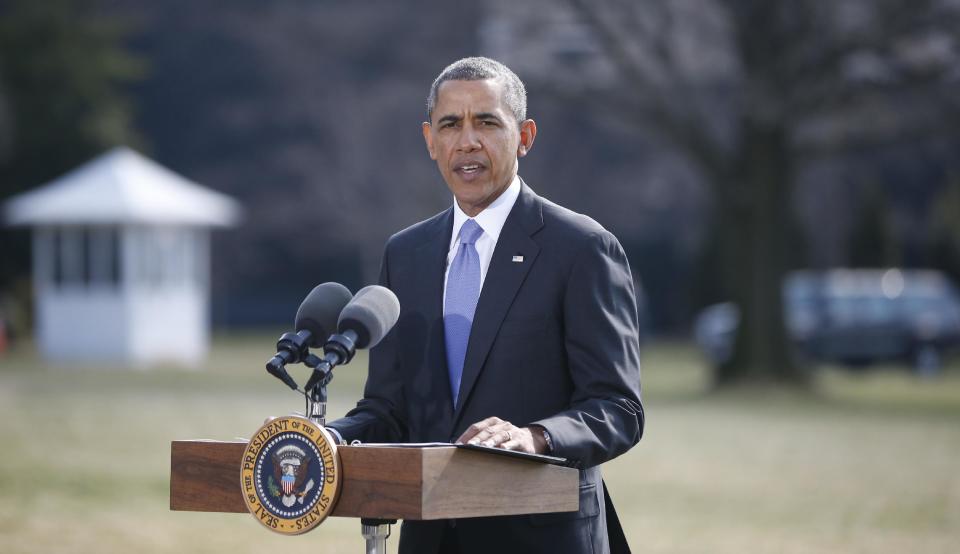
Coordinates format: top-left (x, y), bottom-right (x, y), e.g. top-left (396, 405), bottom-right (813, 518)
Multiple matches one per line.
top-left (454, 184), bottom-right (543, 425)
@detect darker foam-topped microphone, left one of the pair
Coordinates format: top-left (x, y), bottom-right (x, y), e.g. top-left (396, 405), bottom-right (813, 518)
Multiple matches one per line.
top-left (266, 283), bottom-right (353, 390)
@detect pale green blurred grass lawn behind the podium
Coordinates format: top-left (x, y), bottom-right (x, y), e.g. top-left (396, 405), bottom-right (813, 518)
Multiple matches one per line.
top-left (0, 333), bottom-right (960, 554)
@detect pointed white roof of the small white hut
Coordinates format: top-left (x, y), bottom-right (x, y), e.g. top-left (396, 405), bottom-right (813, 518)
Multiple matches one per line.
top-left (4, 146), bottom-right (240, 226)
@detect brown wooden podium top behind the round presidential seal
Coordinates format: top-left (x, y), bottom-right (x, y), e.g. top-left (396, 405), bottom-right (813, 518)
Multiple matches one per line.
top-left (170, 440), bottom-right (579, 552)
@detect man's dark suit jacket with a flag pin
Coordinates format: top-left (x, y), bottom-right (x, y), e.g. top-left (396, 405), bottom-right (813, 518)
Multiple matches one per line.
top-left (330, 184), bottom-right (644, 554)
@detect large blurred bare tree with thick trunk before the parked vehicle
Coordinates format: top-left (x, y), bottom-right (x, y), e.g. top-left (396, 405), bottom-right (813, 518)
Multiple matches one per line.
top-left (571, 0), bottom-right (960, 385)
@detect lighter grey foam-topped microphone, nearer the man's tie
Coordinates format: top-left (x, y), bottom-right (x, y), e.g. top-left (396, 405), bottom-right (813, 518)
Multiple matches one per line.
top-left (304, 285), bottom-right (400, 390)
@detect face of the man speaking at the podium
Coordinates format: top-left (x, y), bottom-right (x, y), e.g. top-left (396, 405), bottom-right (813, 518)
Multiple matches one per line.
top-left (423, 79), bottom-right (537, 217)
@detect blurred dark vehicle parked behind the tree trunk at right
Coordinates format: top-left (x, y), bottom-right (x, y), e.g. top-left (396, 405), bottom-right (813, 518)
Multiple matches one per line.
top-left (694, 269), bottom-right (960, 375)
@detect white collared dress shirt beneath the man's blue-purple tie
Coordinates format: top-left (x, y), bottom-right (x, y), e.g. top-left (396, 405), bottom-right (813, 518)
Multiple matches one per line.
top-left (443, 175), bottom-right (520, 306)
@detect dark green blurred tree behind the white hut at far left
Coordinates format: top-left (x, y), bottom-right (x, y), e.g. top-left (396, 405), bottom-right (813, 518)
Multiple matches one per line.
top-left (0, 0), bottom-right (144, 287)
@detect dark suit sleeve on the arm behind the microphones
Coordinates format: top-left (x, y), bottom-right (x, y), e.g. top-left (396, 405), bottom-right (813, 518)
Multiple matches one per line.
top-left (327, 244), bottom-right (408, 442)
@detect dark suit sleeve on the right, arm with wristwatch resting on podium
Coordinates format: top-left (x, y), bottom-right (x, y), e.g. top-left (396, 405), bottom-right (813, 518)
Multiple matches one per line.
top-left (532, 231), bottom-right (644, 467)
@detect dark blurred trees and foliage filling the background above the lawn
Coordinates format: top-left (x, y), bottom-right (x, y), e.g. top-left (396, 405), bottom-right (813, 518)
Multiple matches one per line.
top-left (0, 0), bottom-right (960, 383)
